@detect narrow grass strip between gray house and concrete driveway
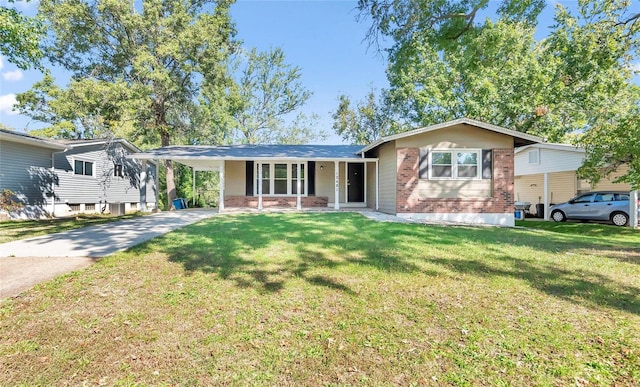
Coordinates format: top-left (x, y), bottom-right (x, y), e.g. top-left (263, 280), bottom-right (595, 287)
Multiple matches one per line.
top-left (0, 212), bottom-right (142, 243)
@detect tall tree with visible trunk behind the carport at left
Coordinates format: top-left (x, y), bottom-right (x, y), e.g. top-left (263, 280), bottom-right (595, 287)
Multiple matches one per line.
top-left (35, 0), bottom-right (236, 207)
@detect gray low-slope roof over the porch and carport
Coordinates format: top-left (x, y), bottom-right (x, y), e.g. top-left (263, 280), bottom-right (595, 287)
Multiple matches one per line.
top-left (133, 144), bottom-right (363, 160)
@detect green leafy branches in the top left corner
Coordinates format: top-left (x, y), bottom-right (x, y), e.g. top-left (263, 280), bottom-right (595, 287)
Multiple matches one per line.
top-left (0, 0), bottom-right (44, 70)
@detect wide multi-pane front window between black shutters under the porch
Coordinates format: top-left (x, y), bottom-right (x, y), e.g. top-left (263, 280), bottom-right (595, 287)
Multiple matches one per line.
top-left (253, 163), bottom-right (307, 196)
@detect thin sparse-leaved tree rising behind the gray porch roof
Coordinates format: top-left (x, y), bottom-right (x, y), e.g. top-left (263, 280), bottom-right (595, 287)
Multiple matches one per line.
top-left (206, 48), bottom-right (324, 144)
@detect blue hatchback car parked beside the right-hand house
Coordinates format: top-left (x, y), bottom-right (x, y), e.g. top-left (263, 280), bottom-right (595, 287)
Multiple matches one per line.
top-left (550, 191), bottom-right (640, 226)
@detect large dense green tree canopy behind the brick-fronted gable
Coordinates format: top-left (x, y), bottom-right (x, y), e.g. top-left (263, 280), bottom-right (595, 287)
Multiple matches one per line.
top-left (352, 0), bottom-right (640, 186)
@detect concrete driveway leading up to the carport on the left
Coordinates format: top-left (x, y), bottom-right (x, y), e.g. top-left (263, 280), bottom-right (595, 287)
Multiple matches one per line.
top-left (0, 209), bottom-right (217, 298)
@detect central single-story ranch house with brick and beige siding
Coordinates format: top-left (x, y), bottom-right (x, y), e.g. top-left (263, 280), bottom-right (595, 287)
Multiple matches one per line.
top-left (130, 118), bottom-right (542, 226)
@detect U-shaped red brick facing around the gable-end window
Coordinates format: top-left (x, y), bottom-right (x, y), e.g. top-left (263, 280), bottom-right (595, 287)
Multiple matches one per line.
top-left (396, 148), bottom-right (514, 214)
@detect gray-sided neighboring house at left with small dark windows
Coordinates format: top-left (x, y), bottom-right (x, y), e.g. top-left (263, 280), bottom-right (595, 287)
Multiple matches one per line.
top-left (0, 130), bottom-right (157, 218)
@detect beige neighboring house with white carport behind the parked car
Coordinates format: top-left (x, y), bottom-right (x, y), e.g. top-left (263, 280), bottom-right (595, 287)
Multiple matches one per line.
top-left (515, 143), bottom-right (630, 219)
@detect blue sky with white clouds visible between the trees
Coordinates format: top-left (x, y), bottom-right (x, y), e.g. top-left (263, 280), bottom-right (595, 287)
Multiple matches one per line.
top-left (0, 0), bottom-right (636, 143)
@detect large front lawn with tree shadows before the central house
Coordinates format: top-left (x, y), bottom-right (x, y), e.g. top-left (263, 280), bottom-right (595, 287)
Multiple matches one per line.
top-left (0, 213), bottom-right (640, 385)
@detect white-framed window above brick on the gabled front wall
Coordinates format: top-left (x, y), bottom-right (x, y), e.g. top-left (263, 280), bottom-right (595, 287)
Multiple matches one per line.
top-left (429, 149), bottom-right (482, 180)
